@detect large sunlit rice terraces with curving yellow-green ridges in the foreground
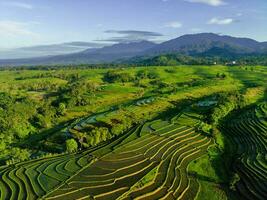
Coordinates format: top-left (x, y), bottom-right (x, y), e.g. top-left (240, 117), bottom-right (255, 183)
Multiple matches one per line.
top-left (0, 113), bottom-right (213, 200)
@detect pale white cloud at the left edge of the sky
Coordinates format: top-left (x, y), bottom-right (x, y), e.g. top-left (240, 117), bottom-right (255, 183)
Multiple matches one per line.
top-left (0, 20), bottom-right (37, 37)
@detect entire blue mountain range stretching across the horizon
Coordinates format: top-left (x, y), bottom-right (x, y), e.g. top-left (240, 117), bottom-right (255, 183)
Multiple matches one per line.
top-left (0, 33), bottom-right (267, 66)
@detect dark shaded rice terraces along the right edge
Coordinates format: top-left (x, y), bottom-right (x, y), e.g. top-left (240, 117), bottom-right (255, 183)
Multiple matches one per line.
top-left (224, 103), bottom-right (267, 200)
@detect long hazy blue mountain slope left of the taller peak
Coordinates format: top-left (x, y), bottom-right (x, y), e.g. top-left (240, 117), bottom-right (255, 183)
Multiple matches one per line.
top-left (0, 41), bottom-right (156, 66)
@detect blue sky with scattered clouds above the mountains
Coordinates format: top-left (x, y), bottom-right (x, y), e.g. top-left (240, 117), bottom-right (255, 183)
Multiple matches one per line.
top-left (0, 0), bottom-right (267, 49)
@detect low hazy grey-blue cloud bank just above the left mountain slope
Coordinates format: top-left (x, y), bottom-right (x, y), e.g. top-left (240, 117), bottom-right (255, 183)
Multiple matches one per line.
top-left (0, 42), bottom-right (107, 59)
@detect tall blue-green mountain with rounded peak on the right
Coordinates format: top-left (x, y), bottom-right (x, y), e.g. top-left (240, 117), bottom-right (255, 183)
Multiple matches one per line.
top-left (145, 33), bottom-right (267, 55)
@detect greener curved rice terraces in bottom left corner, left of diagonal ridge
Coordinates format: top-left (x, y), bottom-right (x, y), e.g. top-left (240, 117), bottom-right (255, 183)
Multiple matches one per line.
top-left (0, 152), bottom-right (96, 199)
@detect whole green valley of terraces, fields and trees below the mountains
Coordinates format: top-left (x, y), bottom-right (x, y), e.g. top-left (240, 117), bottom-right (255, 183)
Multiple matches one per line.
top-left (0, 63), bottom-right (267, 199)
